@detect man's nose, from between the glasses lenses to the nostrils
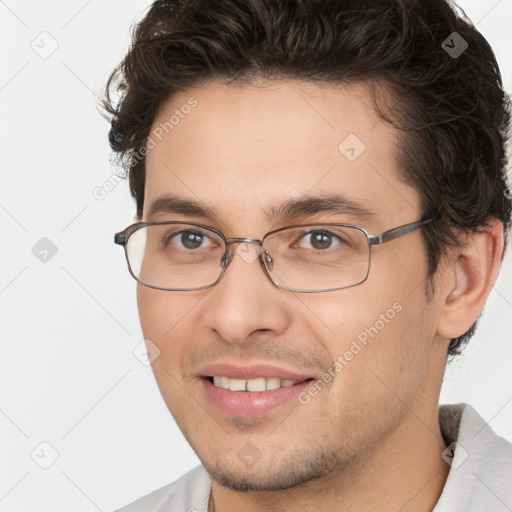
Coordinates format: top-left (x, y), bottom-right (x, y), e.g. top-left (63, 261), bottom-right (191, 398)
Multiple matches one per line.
top-left (205, 239), bottom-right (292, 344)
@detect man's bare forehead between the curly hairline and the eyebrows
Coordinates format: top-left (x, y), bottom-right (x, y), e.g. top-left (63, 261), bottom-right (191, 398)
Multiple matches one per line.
top-left (144, 80), bottom-right (419, 228)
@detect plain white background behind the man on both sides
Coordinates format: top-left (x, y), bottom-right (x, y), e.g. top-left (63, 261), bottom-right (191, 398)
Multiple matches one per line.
top-left (0, 0), bottom-right (512, 512)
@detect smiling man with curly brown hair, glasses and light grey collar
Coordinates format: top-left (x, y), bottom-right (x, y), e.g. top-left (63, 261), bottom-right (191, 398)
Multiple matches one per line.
top-left (106, 0), bottom-right (512, 512)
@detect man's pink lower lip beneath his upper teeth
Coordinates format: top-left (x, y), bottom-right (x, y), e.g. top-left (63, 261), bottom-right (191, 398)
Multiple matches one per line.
top-left (201, 378), bottom-right (313, 419)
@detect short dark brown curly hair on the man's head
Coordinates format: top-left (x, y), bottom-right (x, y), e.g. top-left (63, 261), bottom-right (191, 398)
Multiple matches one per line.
top-left (103, 0), bottom-right (511, 355)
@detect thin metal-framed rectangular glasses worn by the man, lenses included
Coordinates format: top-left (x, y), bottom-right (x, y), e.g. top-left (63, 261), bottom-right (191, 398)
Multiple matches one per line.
top-left (114, 217), bottom-right (436, 293)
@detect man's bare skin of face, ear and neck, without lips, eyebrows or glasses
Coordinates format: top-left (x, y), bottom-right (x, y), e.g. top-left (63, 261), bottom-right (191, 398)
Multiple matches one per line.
top-left (138, 80), bottom-right (503, 512)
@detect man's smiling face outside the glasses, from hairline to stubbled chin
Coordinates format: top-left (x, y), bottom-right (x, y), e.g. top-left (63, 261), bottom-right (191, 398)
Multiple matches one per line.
top-left (138, 81), bottom-right (443, 490)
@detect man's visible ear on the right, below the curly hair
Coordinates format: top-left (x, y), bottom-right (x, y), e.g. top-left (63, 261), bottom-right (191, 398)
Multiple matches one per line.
top-left (437, 219), bottom-right (504, 339)
